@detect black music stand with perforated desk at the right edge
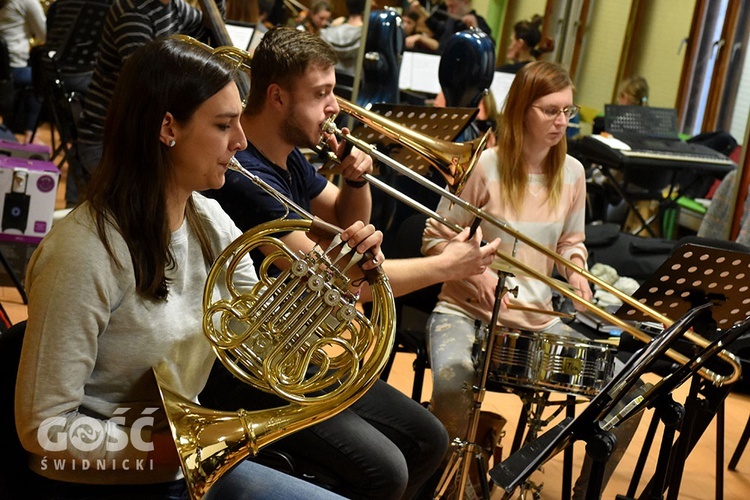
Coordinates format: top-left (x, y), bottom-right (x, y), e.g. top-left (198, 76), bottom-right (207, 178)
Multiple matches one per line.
top-left (617, 243), bottom-right (750, 498)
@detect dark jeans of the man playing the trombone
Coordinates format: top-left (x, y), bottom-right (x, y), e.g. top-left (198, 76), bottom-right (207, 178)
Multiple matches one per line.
top-left (200, 362), bottom-right (448, 500)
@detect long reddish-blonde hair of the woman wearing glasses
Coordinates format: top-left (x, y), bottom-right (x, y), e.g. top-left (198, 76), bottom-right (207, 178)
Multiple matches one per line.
top-left (497, 61), bottom-right (573, 211)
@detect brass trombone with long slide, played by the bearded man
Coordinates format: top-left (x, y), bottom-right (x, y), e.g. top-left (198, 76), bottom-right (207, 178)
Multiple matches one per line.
top-left (323, 97), bottom-right (742, 386)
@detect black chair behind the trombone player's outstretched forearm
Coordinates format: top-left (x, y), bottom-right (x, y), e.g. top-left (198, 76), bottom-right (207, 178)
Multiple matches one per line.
top-left (381, 213), bottom-right (441, 403)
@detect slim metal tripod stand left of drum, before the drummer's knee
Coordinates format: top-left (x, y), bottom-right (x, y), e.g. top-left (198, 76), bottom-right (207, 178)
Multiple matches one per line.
top-left (434, 271), bottom-right (518, 500)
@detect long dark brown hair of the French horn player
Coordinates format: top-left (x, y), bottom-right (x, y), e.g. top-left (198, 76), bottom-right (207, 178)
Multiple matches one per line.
top-left (86, 38), bottom-right (234, 299)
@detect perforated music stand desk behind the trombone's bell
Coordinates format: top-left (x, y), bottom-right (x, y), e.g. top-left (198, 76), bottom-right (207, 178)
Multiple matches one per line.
top-left (352, 103), bottom-right (479, 175)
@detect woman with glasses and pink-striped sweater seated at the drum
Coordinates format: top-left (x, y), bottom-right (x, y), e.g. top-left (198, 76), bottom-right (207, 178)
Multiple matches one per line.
top-left (422, 61), bottom-right (637, 498)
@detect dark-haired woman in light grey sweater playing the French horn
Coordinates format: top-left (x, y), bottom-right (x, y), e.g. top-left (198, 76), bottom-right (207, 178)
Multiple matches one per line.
top-left (15, 38), bottom-right (354, 500)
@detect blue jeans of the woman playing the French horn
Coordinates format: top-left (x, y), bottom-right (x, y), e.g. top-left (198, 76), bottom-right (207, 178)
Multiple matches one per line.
top-left (29, 460), bottom-right (341, 500)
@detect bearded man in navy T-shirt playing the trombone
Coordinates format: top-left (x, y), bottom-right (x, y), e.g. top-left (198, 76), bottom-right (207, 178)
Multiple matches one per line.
top-left (201, 27), bottom-right (499, 499)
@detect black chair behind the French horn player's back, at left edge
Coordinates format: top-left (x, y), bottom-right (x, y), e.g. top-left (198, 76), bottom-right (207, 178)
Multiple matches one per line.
top-left (0, 321), bottom-right (33, 499)
